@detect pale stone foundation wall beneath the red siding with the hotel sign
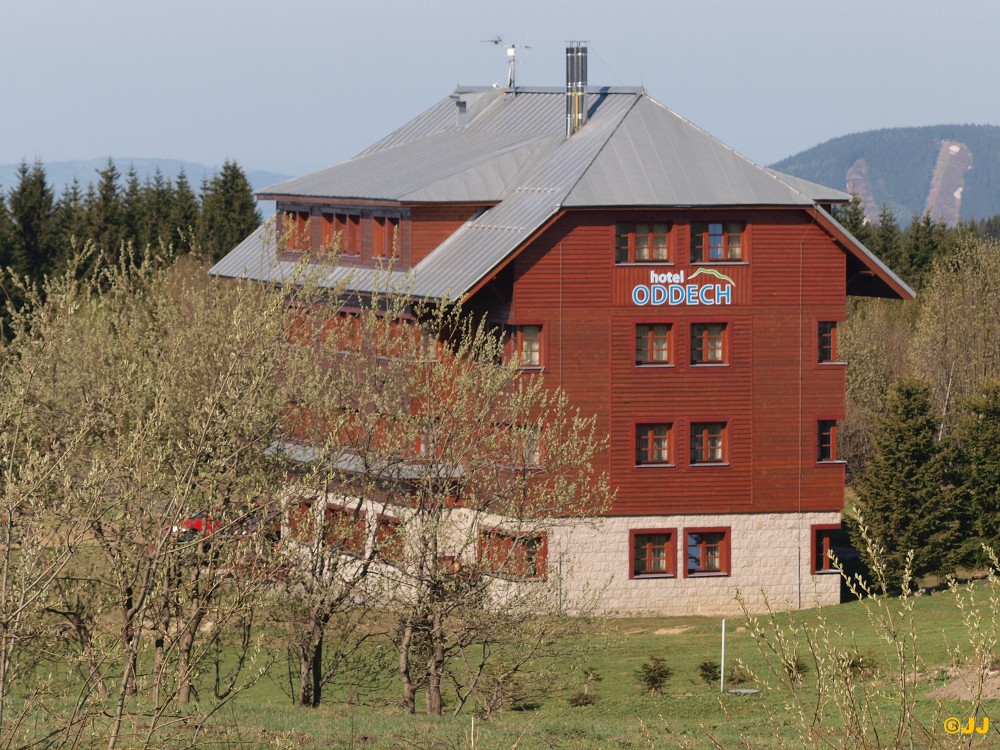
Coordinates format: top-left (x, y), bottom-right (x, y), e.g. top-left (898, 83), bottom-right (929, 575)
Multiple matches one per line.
top-left (548, 512), bottom-right (840, 616)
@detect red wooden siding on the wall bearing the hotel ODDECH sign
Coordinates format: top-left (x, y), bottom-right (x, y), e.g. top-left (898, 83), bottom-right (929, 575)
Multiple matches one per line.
top-left (496, 209), bottom-right (846, 515)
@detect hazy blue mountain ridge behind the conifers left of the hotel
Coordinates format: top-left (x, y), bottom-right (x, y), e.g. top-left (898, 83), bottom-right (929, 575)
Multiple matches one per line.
top-left (0, 156), bottom-right (291, 197)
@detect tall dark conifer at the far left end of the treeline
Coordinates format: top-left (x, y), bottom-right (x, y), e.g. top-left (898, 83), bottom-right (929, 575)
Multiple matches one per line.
top-left (8, 161), bottom-right (55, 282)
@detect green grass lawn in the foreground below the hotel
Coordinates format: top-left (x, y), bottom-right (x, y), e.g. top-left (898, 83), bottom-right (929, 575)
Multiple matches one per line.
top-left (164, 584), bottom-right (1000, 749)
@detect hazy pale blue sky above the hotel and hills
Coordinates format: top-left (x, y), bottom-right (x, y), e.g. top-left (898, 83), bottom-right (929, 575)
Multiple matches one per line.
top-left (0, 0), bottom-right (1000, 174)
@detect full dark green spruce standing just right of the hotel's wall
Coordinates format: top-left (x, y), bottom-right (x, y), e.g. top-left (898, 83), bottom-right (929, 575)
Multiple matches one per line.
top-left (852, 378), bottom-right (960, 588)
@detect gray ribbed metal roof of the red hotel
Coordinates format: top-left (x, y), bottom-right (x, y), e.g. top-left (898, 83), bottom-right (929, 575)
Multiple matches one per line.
top-left (211, 87), bottom-right (884, 298)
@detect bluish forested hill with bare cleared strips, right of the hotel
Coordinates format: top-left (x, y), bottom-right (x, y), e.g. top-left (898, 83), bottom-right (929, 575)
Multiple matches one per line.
top-left (772, 125), bottom-right (1000, 224)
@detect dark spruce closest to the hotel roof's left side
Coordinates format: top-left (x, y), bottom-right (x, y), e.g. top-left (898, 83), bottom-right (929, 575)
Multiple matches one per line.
top-left (200, 160), bottom-right (261, 262)
